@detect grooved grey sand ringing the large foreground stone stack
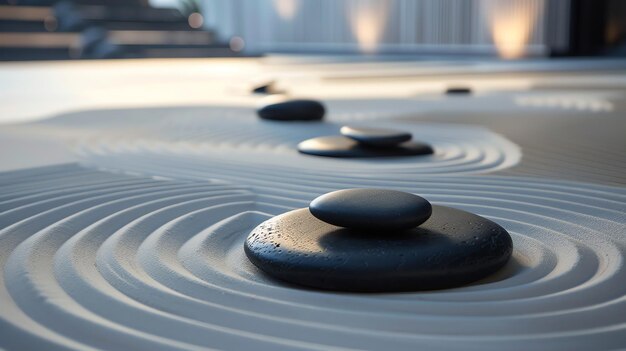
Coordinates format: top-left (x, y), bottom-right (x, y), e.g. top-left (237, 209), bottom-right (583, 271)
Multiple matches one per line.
top-left (0, 164), bottom-right (626, 350)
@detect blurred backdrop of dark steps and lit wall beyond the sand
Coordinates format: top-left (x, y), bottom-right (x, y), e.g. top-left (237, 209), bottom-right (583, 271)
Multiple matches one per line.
top-left (0, 0), bottom-right (626, 61)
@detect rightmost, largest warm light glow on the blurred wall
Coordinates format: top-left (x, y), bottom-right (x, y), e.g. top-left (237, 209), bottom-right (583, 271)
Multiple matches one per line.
top-left (484, 0), bottom-right (543, 59)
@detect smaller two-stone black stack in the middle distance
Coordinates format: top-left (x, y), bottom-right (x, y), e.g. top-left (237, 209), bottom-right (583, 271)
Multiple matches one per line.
top-left (298, 126), bottom-right (434, 158)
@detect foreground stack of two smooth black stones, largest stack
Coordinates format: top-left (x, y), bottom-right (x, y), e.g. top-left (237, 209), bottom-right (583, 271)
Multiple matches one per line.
top-left (244, 189), bottom-right (513, 292)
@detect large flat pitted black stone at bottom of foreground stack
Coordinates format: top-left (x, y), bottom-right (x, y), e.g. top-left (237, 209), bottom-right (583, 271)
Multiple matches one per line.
top-left (244, 206), bottom-right (513, 292)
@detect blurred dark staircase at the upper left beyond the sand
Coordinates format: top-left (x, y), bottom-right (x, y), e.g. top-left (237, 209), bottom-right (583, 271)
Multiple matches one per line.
top-left (0, 0), bottom-right (237, 61)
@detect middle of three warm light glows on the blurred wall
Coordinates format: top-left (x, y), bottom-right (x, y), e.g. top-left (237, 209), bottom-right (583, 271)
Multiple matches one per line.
top-left (347, 0), bottom-right (390, 53)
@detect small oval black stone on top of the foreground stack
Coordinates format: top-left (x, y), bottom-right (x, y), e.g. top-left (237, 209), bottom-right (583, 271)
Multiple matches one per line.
top-left (309, 189), bottom-right (432, 231)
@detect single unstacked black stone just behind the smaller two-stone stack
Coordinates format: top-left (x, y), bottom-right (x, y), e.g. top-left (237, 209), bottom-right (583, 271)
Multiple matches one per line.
top-left (257, 100), bottom-right (326, 121)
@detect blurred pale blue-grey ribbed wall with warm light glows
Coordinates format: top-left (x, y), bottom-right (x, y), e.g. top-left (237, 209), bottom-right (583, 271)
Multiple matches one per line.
top-left (202, 0), bottom-right (570, 57)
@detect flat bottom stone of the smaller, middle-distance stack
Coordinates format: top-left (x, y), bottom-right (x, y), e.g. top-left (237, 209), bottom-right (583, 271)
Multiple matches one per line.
top-left (298, 135), bottom-right (434, 158)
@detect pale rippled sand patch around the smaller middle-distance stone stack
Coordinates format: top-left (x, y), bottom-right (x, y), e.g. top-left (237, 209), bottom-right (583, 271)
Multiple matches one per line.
top-left (44, 107), bottom-right (521, 175)
